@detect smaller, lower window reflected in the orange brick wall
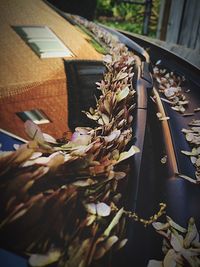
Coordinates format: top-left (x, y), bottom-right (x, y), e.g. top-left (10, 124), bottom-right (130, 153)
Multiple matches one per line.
top-left (16, 109), bottom-right (50, 124)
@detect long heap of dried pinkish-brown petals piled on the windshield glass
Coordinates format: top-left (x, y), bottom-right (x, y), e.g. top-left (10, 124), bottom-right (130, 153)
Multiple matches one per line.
top-left (0, 17), bottom-right (165, 267)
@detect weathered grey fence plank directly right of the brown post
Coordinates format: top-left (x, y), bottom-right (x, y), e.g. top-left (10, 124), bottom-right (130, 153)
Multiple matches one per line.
top-left (166, 0), bottom-right (185, 43)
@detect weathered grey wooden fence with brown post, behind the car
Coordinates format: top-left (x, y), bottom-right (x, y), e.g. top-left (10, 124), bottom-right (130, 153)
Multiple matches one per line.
top-left (157, 0), bottom-right (200, 50)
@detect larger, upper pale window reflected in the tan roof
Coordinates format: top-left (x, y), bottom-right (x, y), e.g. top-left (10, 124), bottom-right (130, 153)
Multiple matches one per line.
top-left (13, 26), bottom-right (74, 58)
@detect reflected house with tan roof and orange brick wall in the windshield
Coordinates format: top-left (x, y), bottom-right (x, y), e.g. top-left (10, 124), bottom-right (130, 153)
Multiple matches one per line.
top-left (0, 0), bottom-right (102, 138)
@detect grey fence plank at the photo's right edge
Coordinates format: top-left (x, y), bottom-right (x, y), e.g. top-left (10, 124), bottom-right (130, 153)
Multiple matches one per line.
top-left (178, 0), bottom-right (200, 48)
